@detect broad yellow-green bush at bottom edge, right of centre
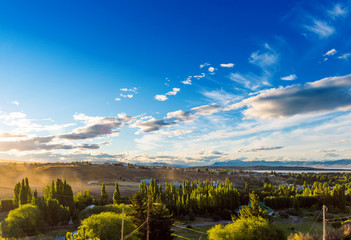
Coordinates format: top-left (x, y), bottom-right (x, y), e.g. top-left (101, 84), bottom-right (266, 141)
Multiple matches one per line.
top-left (207, 217), bottom-right (285, 240)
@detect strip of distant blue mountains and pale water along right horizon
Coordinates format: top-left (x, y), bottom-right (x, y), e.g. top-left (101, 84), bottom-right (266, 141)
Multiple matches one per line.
top-left (209, 159), bottom-right (351, 169)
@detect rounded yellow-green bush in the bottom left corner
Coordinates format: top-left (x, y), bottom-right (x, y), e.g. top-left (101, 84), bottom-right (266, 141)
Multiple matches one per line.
top-left (1, 204), bottom-right (44, 238)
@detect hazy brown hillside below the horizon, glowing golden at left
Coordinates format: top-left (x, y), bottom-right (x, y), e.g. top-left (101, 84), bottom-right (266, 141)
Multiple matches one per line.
top-left (0, 163), bottom-right (278, 198)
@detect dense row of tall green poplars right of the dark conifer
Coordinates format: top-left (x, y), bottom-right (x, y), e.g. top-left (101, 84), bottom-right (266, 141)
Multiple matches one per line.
top-left (135, 178), bottom-right (240, 218)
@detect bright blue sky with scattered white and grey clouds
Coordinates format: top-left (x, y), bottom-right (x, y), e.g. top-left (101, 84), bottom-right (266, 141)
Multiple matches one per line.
top-left (0, 0), bottom-right (351, 166)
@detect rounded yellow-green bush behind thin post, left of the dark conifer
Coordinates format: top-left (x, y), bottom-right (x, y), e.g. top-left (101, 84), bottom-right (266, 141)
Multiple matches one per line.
top-left (80, 212), bottom-right (137, 240)
